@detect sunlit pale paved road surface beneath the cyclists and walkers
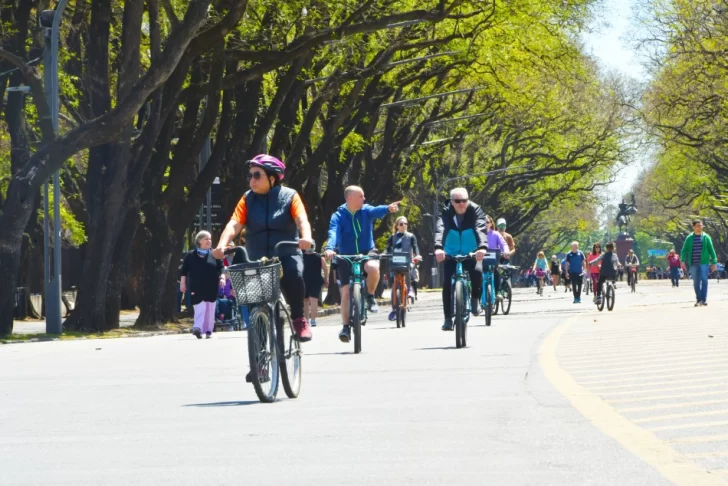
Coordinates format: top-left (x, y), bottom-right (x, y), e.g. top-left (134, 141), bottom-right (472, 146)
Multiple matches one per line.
top-left (0, 283), bottom-right (728, 485)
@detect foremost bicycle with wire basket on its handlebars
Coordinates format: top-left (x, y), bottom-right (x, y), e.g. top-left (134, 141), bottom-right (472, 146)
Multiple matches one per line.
top-left (228, 241), bottom-right (310, 403)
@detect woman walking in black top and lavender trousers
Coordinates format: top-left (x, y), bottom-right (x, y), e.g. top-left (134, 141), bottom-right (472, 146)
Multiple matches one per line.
top-left (180, 231), bottom-right (225, 339)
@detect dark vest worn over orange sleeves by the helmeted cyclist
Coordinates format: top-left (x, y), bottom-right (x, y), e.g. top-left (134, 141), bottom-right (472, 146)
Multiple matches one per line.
top-left (245, 186), bottom-right (301, 260)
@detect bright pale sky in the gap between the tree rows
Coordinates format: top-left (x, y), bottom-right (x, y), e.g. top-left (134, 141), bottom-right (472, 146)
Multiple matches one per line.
top-left (582, 0), bottom-right (648, 204)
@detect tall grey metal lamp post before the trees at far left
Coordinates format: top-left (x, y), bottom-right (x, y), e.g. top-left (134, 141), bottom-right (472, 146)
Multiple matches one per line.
top-left (40, 0), bottom-right (68, 334)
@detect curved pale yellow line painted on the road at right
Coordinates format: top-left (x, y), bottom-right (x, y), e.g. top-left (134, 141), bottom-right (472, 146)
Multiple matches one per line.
top-left (539, 318), bottom-right (728, 486)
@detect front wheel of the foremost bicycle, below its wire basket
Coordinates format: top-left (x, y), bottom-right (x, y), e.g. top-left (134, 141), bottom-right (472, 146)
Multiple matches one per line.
top-left (248, 305), bottom-right (278, 403)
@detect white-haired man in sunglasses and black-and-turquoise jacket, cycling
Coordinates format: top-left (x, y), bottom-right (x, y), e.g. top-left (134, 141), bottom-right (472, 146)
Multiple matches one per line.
top-left (435, 187), bottom-right (488, 331)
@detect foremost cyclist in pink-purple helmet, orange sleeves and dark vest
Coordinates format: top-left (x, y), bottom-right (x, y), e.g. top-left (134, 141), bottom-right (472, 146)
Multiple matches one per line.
top-left (213, 154), bottom-right (313, 348)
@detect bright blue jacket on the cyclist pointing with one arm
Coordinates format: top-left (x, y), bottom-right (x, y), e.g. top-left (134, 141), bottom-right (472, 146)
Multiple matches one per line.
top-left (326, 204), bottom-right (389, 255)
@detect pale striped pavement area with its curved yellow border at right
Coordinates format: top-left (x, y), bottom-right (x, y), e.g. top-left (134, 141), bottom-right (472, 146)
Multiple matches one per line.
top-left (542, 280), bottom-right (728, 484)
